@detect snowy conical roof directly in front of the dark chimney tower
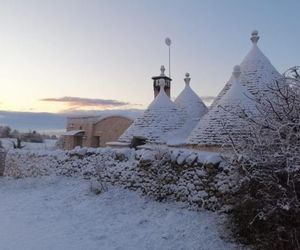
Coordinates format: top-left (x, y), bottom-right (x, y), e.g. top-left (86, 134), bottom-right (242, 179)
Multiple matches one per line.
top-left (118, 79), bottom-right (187, 143)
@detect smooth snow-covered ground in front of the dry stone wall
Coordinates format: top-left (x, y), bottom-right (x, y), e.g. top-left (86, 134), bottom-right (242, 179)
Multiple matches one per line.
top-left (0, 177), bottom-right (240, 250)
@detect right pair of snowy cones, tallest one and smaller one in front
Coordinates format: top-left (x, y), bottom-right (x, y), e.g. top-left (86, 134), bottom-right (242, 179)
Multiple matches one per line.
top-left (186, 31), bottom-right (283, 151)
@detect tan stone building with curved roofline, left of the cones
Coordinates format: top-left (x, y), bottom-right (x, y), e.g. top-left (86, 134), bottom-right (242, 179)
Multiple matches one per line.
top-left (63, 115), bottom-right (133, 150)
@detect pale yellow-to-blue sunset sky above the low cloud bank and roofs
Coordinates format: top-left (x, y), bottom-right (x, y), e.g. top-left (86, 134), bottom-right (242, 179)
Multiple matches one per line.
top-left (0, 0), bottom-right (300, 112)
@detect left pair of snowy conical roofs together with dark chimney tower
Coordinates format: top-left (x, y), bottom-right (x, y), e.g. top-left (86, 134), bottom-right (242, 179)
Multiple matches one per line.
top-left (115, 66), bottom-right (207, 146)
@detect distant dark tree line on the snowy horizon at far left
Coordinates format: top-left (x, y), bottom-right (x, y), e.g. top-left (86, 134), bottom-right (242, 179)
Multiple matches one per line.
top-left (0, 126), bottom-right (57, 143)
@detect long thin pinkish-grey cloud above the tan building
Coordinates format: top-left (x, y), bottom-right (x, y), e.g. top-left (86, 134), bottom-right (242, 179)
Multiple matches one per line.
top-left (40, 96), bottom-right (131, 109)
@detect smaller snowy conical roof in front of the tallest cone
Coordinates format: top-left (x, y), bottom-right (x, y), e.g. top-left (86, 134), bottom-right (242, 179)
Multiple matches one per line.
top-left (187, 66), bottom-right (256, 147)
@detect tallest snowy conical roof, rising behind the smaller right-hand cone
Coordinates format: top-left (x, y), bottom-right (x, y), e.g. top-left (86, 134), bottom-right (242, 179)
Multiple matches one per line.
top-left (211, 31), bottom-right (282, 107)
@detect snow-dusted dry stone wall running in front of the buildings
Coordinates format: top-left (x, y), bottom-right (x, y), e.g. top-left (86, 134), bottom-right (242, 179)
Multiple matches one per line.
top-left (4, 147), bottom-right (238, 210)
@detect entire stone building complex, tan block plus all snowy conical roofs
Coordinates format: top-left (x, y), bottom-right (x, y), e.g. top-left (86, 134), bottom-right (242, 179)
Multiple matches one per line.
top-left (65, 31), bottom-right (283, 151)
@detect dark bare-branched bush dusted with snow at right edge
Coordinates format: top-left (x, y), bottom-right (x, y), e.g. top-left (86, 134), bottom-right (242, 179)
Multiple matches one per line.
top-left (229, 82), bottom-right (300, 250)
